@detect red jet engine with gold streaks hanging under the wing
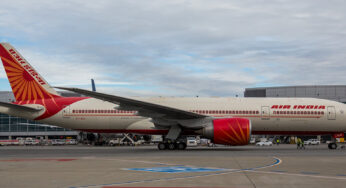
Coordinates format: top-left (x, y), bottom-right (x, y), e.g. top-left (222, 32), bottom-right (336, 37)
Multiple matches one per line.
top-left (199, 118), bottom-right (251, 146)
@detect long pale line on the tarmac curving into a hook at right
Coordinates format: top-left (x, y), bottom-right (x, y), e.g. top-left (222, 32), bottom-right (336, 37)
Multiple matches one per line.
top-left (70, 157), bottom-right (282, 188)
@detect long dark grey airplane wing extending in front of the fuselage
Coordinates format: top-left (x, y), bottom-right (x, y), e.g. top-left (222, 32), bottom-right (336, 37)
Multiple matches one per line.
top-left (56, 87), bottom-right (207, 120)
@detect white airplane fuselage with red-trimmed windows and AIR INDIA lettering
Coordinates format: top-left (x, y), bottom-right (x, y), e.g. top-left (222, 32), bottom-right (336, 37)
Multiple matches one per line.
top-left (33, 97), bottom-right (346, 134)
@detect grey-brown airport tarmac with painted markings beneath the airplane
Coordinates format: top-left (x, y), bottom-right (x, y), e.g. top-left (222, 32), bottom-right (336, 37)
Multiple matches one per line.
top-left (0, 144), bottom-right (346, 188)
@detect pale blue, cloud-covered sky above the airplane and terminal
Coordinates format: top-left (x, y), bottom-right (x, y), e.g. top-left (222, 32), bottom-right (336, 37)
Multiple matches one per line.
top-left (0, 0), bottom-right (346, 97)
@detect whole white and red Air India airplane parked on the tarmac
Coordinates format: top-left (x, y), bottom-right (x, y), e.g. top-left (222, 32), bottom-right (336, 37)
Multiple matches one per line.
top-left (0, 43), bottom-right (346, 150)
